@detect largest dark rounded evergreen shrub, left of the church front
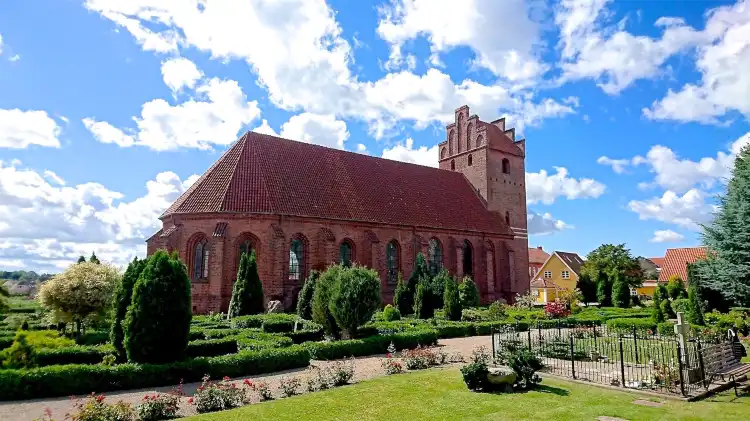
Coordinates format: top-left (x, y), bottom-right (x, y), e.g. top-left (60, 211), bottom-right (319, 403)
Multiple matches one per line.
top-left (123, 250), bottom-right (192, 363)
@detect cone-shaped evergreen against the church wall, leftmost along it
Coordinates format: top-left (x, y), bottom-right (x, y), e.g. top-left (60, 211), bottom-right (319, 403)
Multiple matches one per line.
top-left (227, 250), bottom-right (265, 319)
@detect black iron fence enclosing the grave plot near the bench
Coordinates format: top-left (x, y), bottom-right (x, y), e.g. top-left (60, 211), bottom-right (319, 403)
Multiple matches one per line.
top-left (492, 324), bottom-right (728, 396)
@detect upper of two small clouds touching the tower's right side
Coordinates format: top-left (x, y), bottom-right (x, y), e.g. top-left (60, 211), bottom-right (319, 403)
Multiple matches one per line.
top-left (526, 167), bottom-right (606, 205)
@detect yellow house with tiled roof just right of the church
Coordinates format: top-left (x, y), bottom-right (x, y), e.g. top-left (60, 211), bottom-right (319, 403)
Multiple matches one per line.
top-left (531, 251), bottom-right (584, 304)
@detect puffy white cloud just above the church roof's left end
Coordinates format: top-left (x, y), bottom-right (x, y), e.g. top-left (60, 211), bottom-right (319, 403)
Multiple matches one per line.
top-left (83, 78), bottom-right (260, 151)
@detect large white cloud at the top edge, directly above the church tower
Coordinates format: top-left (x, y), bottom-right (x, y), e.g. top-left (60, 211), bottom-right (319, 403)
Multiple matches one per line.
top-left (377, 0), bottom-right (546, 81)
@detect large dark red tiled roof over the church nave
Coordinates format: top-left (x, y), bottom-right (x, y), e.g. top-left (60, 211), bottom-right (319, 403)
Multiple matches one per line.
top-left (162, 132), bottom-right (509, 233)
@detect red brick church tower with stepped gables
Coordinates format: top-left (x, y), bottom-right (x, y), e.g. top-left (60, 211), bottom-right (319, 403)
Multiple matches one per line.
top-left (438, 105), bottom-right (527, 238)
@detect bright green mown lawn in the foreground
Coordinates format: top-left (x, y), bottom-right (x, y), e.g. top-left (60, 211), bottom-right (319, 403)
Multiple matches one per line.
top-left (189, 369), bottom-right (750, 421)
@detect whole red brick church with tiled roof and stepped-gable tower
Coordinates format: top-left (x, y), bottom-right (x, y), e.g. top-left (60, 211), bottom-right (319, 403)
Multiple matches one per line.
top-left (146, 106), bottom-right (529, 313)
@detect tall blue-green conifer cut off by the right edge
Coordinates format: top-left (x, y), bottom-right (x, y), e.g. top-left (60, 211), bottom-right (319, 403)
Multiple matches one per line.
top-left (699, 145), bottom-right (750, 307)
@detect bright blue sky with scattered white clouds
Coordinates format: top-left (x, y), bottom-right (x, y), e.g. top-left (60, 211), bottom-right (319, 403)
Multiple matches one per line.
top-left (0, 0), bottom-right (750, 272)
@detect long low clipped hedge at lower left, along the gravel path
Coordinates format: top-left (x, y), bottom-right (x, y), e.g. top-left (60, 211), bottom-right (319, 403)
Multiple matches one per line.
top-left (0, 345), bottom-right (310, 400)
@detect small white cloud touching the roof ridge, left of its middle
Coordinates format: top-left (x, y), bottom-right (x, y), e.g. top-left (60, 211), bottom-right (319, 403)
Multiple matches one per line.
top-left (281, 113), bottom-right (349, 149)
